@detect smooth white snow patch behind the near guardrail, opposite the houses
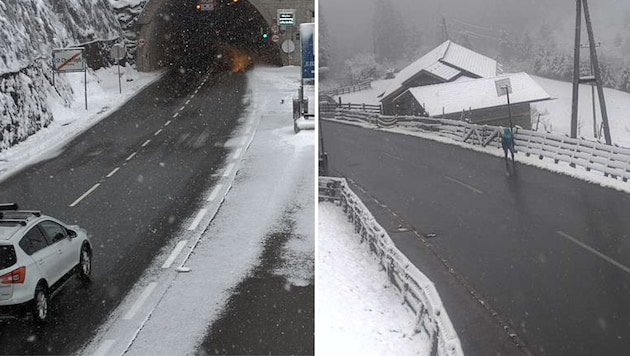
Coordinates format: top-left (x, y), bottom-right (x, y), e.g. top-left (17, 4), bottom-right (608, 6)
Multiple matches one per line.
top-left (315, 203), bottom-right (430, 355)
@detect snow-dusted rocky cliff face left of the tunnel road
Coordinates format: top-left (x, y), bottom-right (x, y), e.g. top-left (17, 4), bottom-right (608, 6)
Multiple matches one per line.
top-left (0, 0), bottom-right (124, 150)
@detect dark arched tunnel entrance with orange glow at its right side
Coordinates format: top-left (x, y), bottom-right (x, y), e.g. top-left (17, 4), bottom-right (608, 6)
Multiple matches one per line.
top-left (137, 0), bottom-right (282, 72)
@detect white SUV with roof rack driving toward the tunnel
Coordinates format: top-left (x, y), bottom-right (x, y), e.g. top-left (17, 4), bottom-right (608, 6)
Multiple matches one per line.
top-left (0, 203), bottom-right (92, 323)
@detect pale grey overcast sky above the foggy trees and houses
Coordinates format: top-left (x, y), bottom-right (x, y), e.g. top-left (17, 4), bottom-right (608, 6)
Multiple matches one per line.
top-left (326, 0), bottom-right (630, 64)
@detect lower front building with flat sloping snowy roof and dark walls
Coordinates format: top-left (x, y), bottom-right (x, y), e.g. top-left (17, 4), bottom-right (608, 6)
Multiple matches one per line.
top-left (393, 73), bottom-right (551, 129)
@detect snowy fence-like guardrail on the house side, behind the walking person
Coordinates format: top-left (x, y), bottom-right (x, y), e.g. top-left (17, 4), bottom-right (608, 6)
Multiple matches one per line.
top-left (322, 108), bottom-right (630, 182)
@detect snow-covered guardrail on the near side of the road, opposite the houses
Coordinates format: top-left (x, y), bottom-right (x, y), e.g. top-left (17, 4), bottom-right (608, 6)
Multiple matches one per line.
top-left (319, 177), bottom-right (464, 356)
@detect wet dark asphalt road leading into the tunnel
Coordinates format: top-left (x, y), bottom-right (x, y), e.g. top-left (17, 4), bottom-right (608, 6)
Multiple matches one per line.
top-left (0, 66), bottom-right (246, 354)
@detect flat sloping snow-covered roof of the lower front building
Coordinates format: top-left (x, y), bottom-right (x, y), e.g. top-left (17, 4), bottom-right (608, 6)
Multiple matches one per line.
top-left (408, 73), bottom-right (551, 115)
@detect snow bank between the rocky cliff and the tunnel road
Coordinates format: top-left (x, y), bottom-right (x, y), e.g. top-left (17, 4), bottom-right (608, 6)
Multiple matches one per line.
top-left (0, 66), bottom-right (162, 179)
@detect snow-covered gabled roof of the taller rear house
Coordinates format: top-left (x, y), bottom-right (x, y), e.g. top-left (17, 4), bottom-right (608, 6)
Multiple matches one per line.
top-left (382, 40), bottom-right (497, 98)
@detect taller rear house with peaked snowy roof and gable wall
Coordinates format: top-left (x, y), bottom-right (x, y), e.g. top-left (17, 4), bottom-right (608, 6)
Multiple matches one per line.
top-left (380, 40), bottom-right (499, 115)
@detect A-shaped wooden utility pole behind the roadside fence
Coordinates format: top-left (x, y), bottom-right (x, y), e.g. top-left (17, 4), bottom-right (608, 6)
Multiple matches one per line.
top-left (571, 0), bottom-right (612, 145)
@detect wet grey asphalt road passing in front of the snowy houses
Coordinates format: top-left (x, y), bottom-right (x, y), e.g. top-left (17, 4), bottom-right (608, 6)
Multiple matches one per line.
top-left (322, 122), bottom-right (630, 355)
